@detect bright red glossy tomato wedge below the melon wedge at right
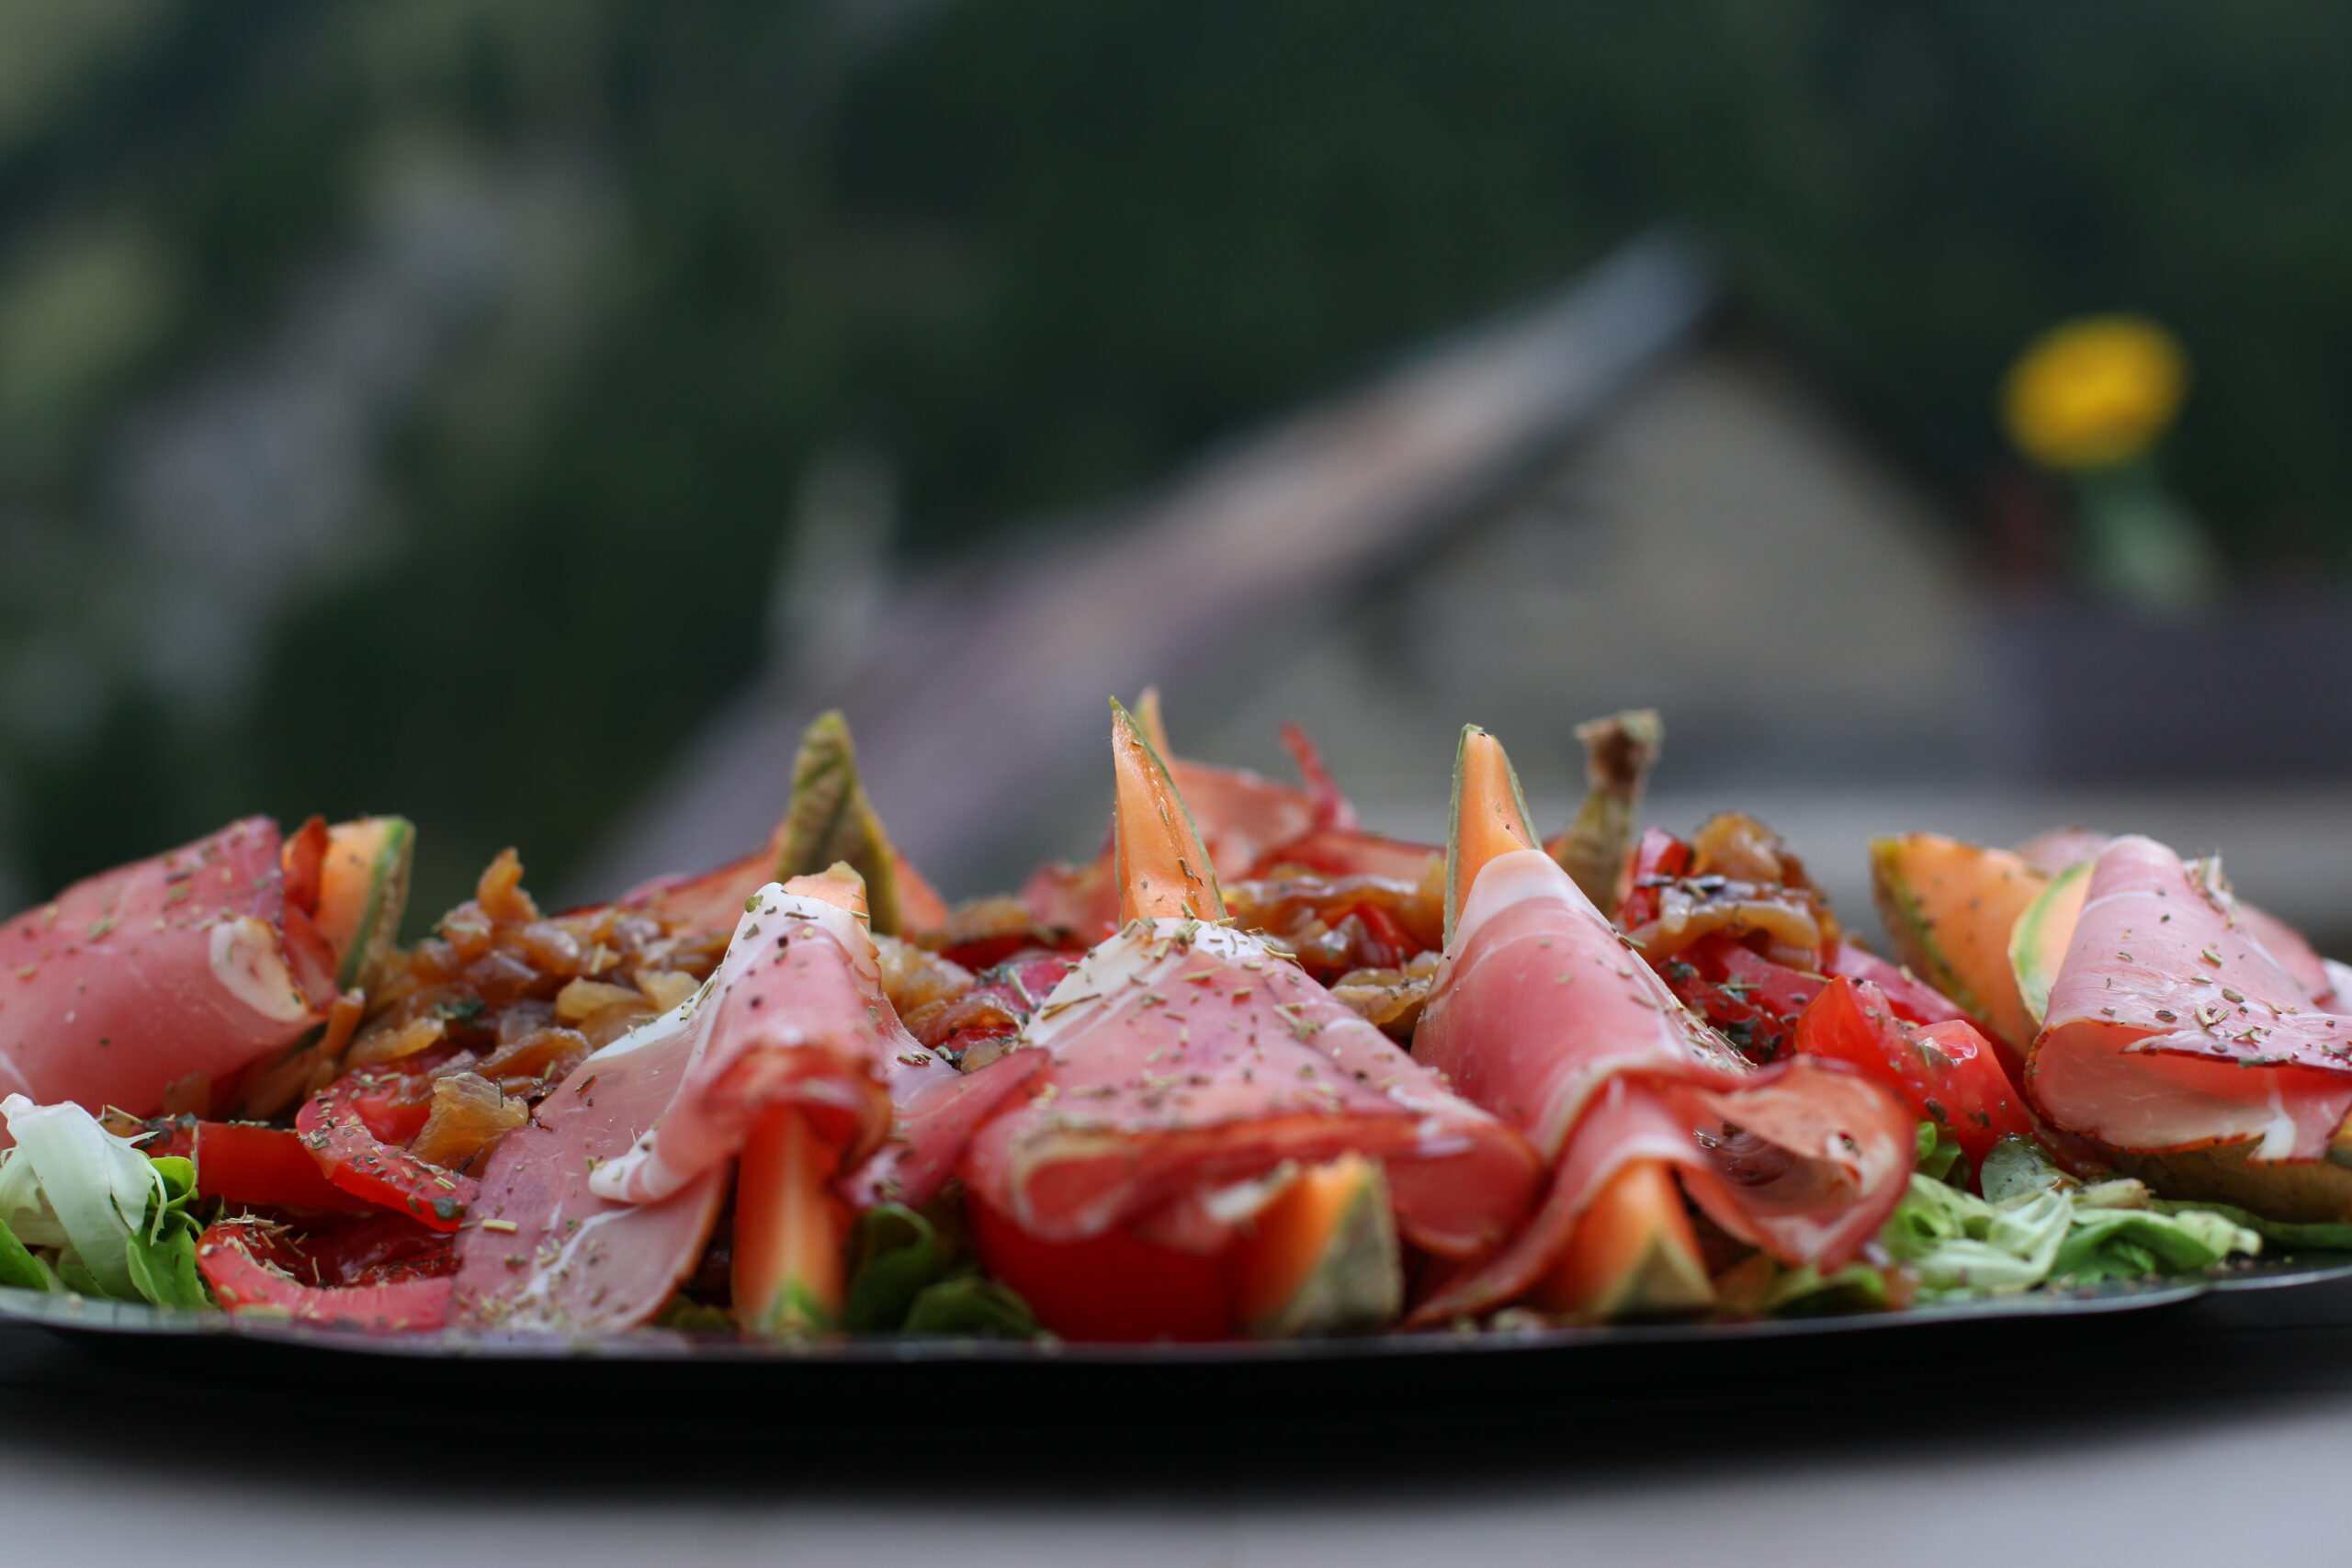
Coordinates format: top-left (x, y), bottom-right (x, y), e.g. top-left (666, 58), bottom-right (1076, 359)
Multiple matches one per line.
top-left (1797, 976), bottom-right (2034, 1170)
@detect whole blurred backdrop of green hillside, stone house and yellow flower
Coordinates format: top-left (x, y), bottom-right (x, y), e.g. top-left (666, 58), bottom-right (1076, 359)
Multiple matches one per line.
top-left (0, 0), bottom-right (2352, 941)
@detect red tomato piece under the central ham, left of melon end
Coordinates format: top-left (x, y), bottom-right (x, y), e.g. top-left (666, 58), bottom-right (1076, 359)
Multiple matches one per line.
top-left (971, 1199), bottom-right (1232, 1342)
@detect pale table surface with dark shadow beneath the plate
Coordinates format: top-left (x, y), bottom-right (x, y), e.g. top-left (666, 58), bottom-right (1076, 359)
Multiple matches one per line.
top-left (0, 1286), bottom-right (2352, 1568)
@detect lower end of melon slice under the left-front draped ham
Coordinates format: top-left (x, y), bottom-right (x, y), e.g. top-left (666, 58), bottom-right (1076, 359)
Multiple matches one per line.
top-left (734, 1105), bottom-right (849, 1340)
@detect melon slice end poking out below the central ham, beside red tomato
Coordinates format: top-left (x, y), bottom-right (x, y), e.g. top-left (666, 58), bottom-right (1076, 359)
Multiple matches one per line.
top-left (1226, 1155), bottom-right (1404, 1340)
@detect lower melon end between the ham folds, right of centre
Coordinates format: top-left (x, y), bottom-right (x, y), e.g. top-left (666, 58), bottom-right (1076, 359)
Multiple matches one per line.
top-left (1533, 1159), bottom-right (1714, 1324)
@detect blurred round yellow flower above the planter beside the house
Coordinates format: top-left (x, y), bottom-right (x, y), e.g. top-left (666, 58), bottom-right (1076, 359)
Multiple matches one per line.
top-left (2002, 315), bottom-right (2188, 468)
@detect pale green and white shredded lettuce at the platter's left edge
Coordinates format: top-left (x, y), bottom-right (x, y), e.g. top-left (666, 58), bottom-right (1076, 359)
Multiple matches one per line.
top-left (0, 1096), bottom-right (211, 1307)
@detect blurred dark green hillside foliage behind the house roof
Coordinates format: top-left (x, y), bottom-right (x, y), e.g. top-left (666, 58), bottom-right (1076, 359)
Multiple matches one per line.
top-left (0, 0), bottom-right (2352, 908)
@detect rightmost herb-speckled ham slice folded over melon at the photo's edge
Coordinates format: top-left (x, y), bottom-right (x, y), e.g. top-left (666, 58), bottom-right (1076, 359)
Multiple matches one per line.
top-left (2025, 837), bottom-right (2352, 1161)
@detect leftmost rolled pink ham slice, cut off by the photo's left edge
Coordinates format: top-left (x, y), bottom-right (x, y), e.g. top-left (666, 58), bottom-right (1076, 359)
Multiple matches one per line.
top-left (0, 816), bottom-right (334, 1117)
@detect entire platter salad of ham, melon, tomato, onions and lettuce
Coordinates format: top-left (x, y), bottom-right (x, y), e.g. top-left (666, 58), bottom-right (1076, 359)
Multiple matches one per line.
top-left (0, 694), bottom-right (2352, 1345)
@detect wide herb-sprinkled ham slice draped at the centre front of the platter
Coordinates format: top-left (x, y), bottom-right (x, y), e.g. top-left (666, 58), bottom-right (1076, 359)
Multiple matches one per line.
top-left (965, 919), bottom-right (1541, 1258)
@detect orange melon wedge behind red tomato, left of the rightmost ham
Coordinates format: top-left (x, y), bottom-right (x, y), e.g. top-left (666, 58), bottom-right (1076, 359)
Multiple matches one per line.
top-left (1870, 832), bottom-right (2049, 1053)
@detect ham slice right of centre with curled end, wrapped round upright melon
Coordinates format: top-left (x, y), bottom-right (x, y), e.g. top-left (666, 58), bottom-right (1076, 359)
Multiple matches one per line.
top-left (1414, 849), bottom-right (1912, 1324)
